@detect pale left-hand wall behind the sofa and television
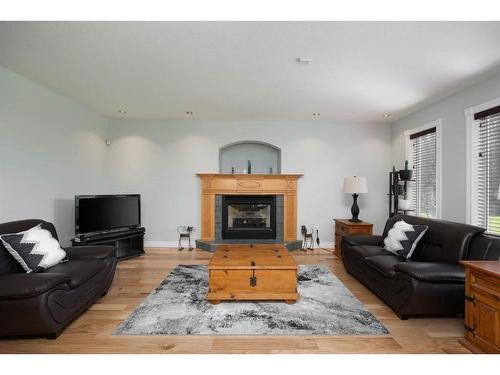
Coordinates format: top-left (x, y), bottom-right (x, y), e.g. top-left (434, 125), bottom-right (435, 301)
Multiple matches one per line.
top-left (0, 68), bottom-right (107, 245)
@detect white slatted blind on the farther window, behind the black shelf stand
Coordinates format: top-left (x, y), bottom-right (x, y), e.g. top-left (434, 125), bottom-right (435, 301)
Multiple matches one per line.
top-left (408, 127), bottom-right (437, 218)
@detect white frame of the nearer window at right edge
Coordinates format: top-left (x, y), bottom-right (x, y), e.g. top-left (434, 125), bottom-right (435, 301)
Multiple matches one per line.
top-left (464, 98), bottom-right (500, 229)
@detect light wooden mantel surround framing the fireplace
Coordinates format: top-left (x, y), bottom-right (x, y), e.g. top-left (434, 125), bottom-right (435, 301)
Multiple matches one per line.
top-left (196, 173), bottom-right (302, 241)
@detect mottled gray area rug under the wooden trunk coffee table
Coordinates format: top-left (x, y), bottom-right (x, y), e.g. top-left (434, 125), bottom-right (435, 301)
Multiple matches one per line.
top-left (114, 265), bottom-right (388, 335)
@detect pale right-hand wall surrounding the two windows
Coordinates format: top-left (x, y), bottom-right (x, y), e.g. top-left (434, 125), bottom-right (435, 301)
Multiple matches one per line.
top-left (392, 71), bottom-right (500, 222)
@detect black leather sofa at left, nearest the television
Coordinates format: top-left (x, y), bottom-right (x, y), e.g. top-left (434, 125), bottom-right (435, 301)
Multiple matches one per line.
top-left (0, 219), bottom-right (117, 338)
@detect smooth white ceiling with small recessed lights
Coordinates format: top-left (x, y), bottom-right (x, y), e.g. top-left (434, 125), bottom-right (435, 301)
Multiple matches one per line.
top-left (0, 22), bottom-right (500, 122)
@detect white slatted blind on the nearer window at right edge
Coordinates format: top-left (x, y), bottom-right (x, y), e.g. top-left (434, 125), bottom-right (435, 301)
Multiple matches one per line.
top-left (472, 106), bottom-right (500, 235)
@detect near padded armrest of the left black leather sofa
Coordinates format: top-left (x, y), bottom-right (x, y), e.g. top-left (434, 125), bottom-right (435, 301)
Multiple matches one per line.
top-left (0, 273), bottom-right (71, 299)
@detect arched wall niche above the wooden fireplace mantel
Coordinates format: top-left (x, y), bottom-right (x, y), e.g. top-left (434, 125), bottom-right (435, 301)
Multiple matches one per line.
top-left (219, 140), bottom-right (281, 174)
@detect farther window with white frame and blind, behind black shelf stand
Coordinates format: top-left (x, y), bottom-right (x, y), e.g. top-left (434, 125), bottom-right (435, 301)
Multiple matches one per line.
top-left (406, 120), bottom-right (441, 218)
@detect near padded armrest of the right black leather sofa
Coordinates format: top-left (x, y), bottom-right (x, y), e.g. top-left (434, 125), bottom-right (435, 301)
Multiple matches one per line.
top-left (394, 262), bottom-right (465, 283)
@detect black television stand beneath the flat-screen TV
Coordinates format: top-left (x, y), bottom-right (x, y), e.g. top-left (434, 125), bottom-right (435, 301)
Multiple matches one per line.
top-left (71, 227), bottom-right (146, 260)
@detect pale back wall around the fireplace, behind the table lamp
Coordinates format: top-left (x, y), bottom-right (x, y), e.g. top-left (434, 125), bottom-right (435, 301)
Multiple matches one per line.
top-left (108, 120), bottom-right (391, 246)
